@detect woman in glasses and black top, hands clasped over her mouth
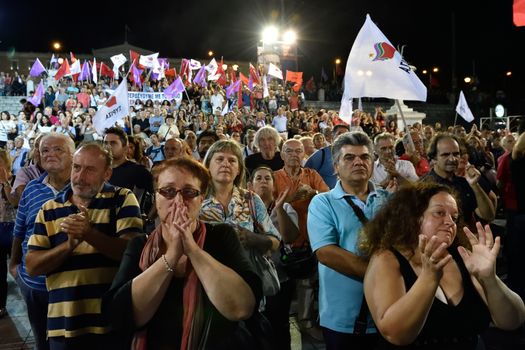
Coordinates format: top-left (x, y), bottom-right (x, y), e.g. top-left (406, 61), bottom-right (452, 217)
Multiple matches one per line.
top-left (104, 158), bottom-right (261, 350)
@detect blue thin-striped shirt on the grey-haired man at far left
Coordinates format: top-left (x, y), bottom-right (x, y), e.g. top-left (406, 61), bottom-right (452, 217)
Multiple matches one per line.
top-left (13, 173), bottom-right (58, 292)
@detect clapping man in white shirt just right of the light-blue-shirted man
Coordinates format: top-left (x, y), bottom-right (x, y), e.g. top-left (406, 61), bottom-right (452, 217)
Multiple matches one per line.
top-left (370, 133), bottom-right (419, 188)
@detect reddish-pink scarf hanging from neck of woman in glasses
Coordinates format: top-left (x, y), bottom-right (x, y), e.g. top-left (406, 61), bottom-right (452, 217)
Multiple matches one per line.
top-left (131, 221), bottom-right (206, 350)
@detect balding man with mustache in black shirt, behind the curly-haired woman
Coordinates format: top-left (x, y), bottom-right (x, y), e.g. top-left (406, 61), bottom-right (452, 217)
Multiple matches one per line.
top-left (421, 133), bottom-right (496, 227)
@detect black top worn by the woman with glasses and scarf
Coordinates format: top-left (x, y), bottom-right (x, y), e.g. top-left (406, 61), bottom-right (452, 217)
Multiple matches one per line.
top-left (104, 224), bottom-right (262, 349)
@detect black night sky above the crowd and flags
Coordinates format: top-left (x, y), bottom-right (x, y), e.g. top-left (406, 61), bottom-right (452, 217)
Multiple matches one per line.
top-left (0, 0), bottom-right (525, 101)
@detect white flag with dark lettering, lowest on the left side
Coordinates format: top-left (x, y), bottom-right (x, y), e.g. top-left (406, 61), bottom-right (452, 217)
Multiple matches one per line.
top-left (93, 79), bottom-right (129, 135)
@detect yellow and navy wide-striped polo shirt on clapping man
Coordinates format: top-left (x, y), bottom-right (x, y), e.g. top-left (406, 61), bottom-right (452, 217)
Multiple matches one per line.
top-left (28, 183), bottom-right (142, 338)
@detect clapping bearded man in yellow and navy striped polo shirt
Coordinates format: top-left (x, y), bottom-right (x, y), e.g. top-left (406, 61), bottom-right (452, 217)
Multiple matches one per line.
top-left (26, 143), bottom-right (142, 350)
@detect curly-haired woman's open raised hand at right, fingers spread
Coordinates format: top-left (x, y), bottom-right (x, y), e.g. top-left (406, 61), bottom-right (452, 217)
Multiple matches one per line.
top-left (458, 222), bottom-right (501, 281)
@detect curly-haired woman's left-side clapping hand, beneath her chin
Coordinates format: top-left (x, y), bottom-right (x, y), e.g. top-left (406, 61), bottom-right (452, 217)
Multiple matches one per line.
top-left (418, 235), bottom-right (452, 281)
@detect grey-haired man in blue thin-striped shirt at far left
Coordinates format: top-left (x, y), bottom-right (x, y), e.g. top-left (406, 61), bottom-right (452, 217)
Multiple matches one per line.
top-left (9, 133), bottom-right (75, 350)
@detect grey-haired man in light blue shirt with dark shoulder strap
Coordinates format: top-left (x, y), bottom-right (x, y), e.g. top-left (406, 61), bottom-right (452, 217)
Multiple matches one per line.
top-left (307, 131), bottom-right (395, 349)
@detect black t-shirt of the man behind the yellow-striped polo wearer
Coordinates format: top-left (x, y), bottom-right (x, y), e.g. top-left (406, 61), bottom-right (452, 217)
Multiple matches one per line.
top-left (109, 160), bottom-right (153, 193)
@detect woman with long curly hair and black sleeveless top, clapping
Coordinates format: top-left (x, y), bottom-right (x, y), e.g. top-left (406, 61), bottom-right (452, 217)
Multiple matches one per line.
top-left (361, 182), bottom-right (525, 349)
